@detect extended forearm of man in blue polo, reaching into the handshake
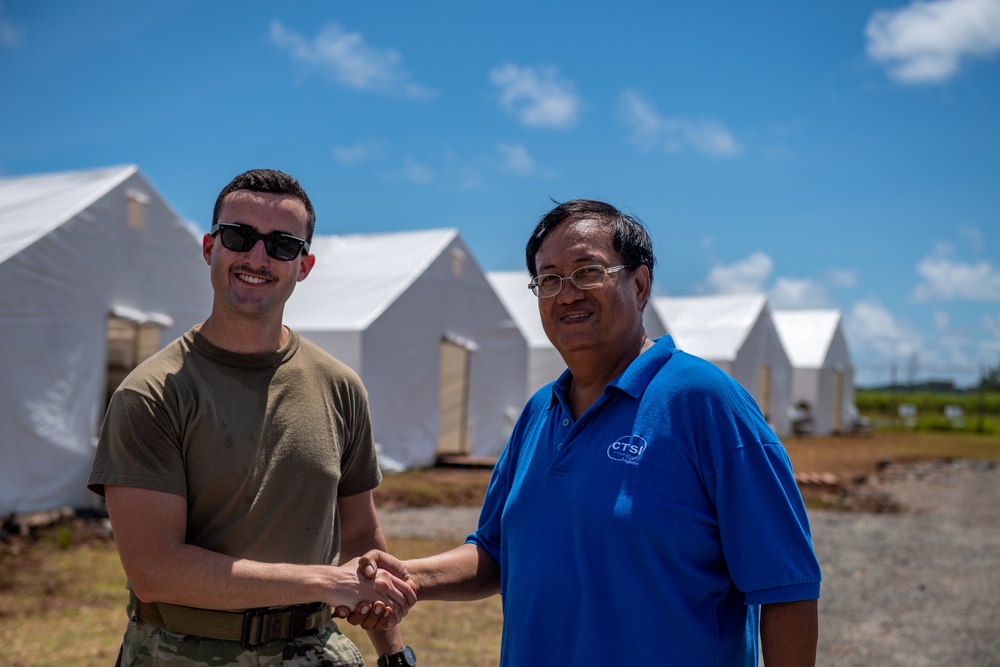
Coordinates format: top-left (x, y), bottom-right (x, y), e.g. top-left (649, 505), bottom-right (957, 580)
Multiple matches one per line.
top-left (405, 544), bottom-right (500, 601)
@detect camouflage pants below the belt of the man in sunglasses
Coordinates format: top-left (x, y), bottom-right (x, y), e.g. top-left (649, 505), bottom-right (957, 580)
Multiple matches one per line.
top-left (121, 620), bottom-right (365, 667)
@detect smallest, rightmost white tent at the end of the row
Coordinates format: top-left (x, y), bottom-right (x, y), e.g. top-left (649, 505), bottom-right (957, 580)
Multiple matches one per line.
top-left (773, 309), bottom-right (854, 435)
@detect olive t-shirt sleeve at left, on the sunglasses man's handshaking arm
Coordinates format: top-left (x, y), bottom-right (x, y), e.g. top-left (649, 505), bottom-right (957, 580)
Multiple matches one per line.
top-left (87, 389), bottom-right (187, 497)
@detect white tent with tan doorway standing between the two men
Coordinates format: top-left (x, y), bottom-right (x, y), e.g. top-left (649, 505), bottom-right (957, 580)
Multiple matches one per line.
top-left (285, 229), bottom-right (527, 469)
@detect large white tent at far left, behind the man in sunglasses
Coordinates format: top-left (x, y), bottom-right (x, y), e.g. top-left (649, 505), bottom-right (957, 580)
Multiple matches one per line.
top-left (0, 165), bottom-right (212, 516)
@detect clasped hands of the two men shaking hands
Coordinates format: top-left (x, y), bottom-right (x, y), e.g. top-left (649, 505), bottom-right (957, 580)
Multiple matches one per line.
top-left (331, 549), bottom-right (417, 630)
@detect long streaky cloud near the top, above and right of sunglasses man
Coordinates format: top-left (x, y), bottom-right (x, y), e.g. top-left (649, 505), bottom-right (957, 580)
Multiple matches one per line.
top-left (270, 21), bottom-right (433, 99)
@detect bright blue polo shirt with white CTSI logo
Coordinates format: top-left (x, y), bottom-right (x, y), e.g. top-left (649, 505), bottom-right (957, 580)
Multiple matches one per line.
top-left (468, 336), bottom-right (820, 667)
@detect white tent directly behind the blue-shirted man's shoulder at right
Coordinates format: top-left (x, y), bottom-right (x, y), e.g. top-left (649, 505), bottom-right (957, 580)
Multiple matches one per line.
top-left (653, 294), bottom-right (792, 435)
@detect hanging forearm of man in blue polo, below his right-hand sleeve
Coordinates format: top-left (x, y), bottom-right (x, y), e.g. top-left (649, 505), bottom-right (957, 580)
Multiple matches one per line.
top-left (760, 600), bottom-right (819, 667)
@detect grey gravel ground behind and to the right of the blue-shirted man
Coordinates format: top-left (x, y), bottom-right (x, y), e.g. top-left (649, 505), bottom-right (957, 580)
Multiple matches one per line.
top-left (379, 461), bottom-right (1000, 667)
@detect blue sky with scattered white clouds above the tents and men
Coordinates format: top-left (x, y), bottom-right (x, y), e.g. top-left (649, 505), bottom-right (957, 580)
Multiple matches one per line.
top-left (0, 0), bottom-right (1000, 384)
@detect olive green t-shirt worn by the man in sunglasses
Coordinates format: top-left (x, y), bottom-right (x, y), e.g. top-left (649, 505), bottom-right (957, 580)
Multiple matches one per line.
top-left (87, 329), bottom-right (381, 564)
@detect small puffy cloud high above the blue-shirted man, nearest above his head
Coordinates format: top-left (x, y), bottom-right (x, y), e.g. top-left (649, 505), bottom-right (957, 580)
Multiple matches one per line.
top-left (490, 63), bottom-right (583, 129)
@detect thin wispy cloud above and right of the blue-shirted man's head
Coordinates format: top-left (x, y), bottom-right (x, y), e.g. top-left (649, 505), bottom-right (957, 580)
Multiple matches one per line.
top-left (621, 90), bottom-right (742, 157)
